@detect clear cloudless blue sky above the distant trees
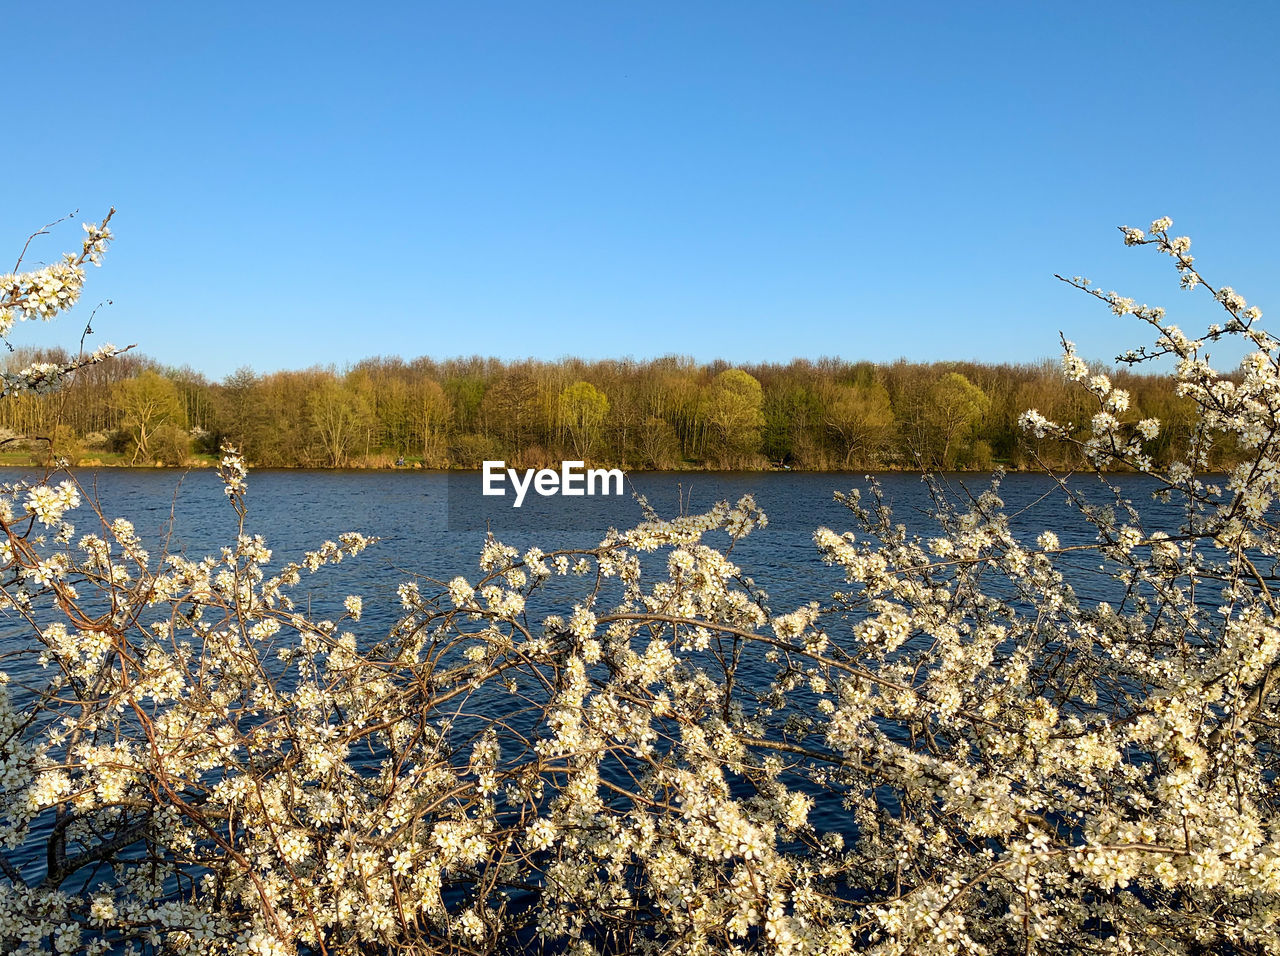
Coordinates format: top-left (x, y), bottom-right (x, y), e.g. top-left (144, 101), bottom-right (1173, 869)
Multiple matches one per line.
top-left (0, 0), bottom-right (1280, 378)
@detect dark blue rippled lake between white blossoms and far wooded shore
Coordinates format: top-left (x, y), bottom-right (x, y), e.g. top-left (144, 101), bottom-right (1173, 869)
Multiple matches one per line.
top-left (0, 468), bottom-right (1178, 627)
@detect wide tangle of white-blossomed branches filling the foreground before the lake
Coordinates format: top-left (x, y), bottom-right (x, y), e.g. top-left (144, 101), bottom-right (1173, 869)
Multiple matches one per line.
top-left (0, 220), bottom-right (1280, 956)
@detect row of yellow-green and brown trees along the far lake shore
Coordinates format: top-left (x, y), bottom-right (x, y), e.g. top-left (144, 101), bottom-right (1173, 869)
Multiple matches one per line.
top-left (0, 349), bottom-right (1229, 470)
